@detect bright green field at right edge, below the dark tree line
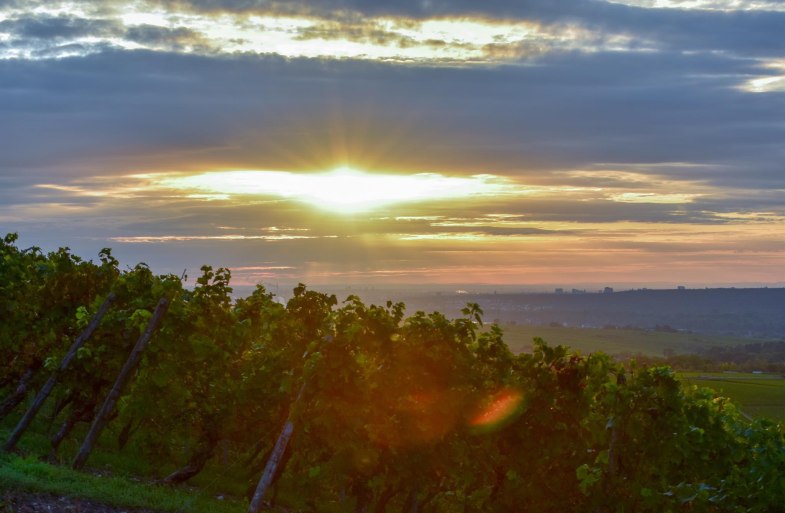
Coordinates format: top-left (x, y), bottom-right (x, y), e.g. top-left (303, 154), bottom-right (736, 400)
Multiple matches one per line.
top-left (679, 372), bottom-right (785, 421)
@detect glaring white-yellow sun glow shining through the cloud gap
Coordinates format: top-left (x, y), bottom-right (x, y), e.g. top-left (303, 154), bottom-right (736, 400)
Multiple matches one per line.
top-left (154, 167), bottom-right (508, 213)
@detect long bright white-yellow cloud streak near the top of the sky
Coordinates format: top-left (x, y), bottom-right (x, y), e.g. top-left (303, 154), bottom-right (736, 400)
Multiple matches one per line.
top-left (0, 3), bottom-right (656, 66)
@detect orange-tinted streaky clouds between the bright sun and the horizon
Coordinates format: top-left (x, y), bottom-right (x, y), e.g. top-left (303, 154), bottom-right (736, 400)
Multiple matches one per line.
top-left (7, 171), bottom-right (785, 284)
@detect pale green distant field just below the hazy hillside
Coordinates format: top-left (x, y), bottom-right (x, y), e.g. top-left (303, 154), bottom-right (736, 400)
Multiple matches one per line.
top-left (503, 325), bottom-right (759, 356)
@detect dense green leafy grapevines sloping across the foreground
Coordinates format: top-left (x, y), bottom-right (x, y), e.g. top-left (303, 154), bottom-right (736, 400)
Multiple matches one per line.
top-left (0, 234), bottom-right (785, 513)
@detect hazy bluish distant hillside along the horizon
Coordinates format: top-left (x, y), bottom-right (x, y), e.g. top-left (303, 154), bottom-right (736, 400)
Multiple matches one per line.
top-left (372, 288), bottom-right (785, 339)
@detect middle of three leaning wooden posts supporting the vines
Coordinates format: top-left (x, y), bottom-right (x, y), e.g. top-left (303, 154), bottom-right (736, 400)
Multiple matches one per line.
top-left (73, 298), bottom-right (169, 470)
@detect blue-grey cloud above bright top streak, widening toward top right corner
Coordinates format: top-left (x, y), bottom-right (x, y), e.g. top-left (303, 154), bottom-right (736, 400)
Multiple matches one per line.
top-left (153, 0), bottom-right (785, 56)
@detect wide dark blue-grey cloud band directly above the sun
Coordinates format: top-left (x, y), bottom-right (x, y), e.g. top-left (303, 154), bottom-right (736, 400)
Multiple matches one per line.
top-left (0, 47), bottom-right (785, 187)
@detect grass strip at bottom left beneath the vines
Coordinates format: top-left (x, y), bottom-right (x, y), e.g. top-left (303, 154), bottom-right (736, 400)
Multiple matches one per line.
top-left (0, 454), bottom-right (246, 513)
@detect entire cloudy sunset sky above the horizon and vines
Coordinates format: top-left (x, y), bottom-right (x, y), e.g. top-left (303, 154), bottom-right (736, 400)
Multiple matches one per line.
top-left (0, 0), bottom-right (785, 287)
